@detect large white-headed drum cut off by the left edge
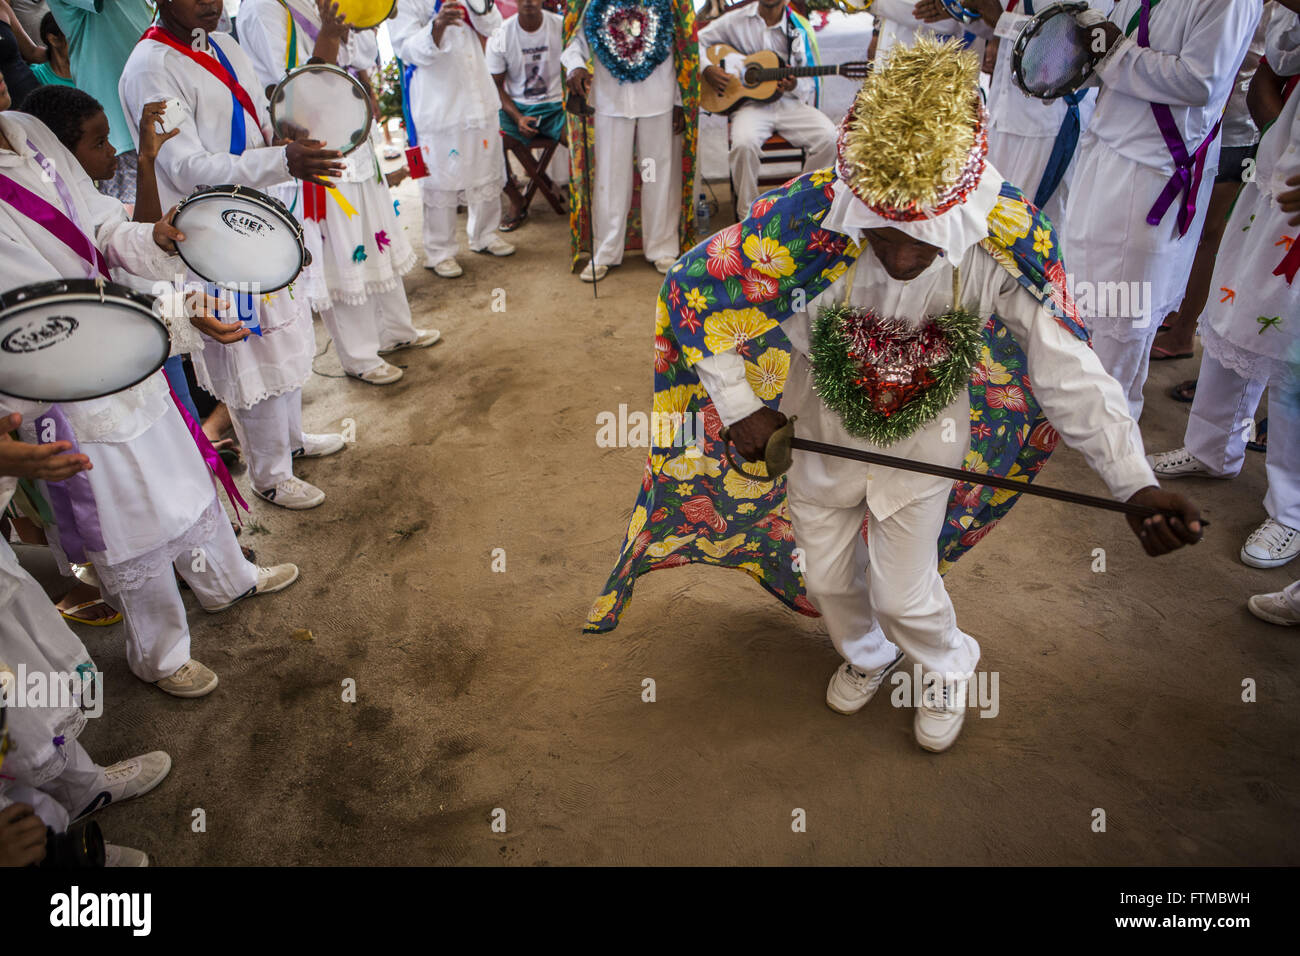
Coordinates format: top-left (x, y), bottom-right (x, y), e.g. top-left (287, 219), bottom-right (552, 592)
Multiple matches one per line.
top-left (0, 278), bottom-right (172, 402)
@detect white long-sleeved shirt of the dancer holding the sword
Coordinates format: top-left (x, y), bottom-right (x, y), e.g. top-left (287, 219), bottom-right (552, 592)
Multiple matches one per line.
top-left (694, 236), bottom-right (1157, 519)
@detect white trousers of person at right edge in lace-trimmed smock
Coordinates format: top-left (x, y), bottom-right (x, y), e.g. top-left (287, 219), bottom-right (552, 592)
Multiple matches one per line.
top-left (1184, 352), bottom-right (1300, 528)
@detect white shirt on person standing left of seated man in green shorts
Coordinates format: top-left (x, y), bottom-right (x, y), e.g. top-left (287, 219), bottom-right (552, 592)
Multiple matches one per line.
top-left (389, 0), bottom-right (502, 138)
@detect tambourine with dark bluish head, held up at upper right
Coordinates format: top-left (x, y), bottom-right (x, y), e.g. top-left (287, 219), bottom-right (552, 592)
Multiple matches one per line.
top-left (1011, 3), bottom-right (1102, 100)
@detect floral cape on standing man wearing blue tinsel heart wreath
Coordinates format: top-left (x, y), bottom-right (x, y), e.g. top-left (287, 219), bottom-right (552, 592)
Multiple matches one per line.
top-left (564, 0), bottom-right (699, 271)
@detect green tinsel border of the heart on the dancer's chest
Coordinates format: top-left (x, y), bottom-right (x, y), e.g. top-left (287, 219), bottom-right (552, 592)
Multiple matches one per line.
top-left (809, 307), bottom-right (984, 447)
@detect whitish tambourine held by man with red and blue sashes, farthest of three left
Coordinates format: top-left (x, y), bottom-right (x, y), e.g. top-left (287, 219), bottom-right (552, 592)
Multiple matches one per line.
top-left (270, 64), bottom-right (374, 156)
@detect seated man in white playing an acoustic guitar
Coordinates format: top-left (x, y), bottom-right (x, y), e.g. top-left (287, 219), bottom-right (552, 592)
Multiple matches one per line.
top-left (699, 0), bottom-right (835, 215)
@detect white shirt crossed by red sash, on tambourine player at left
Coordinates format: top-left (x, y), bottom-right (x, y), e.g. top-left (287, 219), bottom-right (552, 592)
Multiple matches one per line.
top-left (118, 34), bottom-right (290, 209)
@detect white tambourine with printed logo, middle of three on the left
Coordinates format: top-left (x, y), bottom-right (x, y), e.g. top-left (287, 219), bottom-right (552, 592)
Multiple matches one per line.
top-left (173, 186), bottom-right (311, 294)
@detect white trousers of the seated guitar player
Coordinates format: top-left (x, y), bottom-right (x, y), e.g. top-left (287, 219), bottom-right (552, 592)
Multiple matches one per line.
top-left (729, 96), bottom-right (836, 216)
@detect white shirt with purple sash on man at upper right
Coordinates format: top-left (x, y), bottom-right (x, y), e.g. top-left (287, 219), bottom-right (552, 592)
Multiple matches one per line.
top-left (1088, 0), bottom-right (1264, 176)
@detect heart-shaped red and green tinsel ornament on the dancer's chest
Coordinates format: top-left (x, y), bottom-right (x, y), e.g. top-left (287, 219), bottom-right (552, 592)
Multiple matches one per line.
top-left (809, 269), bottom-right (984, 447)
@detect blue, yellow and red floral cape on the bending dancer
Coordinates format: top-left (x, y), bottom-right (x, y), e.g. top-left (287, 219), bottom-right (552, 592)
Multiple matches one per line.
top-left (584, 169), bottom-right (1088, 633)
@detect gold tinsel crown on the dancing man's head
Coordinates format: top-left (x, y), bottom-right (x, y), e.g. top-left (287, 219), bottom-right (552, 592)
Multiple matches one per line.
top-left (837, 36), bottom-right (988, 220)
